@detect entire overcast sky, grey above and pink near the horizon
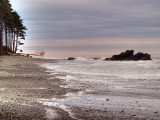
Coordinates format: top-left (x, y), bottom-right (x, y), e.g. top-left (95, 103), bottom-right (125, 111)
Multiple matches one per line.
top-left (10, 0), bottom-right (160, 57)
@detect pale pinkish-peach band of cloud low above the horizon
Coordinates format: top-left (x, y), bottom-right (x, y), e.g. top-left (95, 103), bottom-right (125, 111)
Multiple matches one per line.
top-left (25, 39), bottom-right (160, 53)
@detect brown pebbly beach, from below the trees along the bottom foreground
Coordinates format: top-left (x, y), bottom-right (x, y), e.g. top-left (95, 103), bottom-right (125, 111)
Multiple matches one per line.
top-left (0, 56), bottom-right (159, 120)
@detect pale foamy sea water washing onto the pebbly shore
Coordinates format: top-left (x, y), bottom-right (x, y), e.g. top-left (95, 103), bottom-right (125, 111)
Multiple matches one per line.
top-left (39, 57), bottom-right (160, 119)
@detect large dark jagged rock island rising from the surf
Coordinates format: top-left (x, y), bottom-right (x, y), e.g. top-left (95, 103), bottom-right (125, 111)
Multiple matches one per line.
top-left (104, 50), bottom-right (151, 61)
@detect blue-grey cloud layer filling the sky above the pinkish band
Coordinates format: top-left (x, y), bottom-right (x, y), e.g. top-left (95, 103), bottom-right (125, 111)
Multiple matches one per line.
top-left (11, 0), bottom-right (160, 56)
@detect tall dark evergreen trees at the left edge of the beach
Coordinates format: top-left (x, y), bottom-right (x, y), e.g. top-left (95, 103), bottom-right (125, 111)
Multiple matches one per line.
top-left (0, 0), bottom-right (27, 55)
